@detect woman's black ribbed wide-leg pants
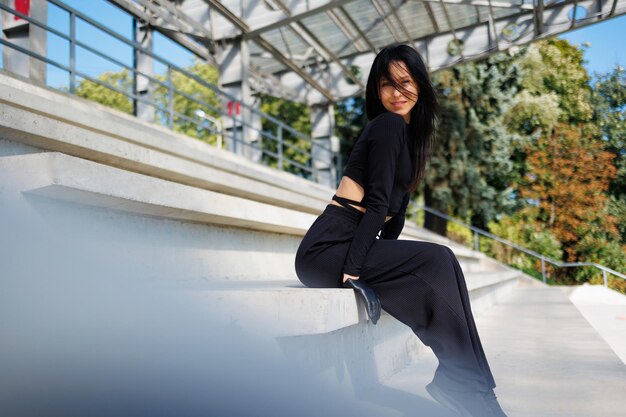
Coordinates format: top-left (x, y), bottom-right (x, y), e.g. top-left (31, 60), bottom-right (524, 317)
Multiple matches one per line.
top-left (295, 204), bottom-right (496, 391)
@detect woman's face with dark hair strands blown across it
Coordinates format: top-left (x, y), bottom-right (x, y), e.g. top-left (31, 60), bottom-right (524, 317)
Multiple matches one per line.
top-left (378, 61), bottom-right (419, 124)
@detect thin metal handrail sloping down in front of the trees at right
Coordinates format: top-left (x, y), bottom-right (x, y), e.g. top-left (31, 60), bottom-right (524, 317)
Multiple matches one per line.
top-left (412, 205), bottom-right (626, 288)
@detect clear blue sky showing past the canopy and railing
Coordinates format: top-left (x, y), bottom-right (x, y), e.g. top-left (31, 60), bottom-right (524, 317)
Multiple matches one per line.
top-left (0, 0), bottom-right (626, 88)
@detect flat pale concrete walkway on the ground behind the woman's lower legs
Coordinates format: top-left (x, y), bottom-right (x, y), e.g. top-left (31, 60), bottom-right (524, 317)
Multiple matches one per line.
top-left (366, 287), bottom-right (626, 417)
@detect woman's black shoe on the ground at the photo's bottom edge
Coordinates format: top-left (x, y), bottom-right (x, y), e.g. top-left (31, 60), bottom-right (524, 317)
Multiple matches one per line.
top-left (426, 382), bottom-right (506, 417)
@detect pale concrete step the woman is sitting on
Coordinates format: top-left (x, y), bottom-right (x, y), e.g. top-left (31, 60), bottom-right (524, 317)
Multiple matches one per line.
top-left (194, 270), bottom-right (526, 336)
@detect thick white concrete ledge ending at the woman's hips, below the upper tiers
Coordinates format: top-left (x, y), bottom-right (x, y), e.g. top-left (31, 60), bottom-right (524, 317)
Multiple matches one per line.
top-left (0, 152), bottom-right (315, 235)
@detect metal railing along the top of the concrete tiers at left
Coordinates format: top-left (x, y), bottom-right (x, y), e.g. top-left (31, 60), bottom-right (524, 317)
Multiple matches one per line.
top-left (0, 0), bottom-right (334, 181)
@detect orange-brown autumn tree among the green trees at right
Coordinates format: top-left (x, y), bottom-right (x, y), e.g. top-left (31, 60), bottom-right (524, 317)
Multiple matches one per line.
top-left (520, 124), bottom-right (617, 261)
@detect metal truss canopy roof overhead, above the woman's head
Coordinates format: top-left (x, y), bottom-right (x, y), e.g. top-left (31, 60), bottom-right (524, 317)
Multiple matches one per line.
top-left (110, 0), bottom-right (626, 105)
